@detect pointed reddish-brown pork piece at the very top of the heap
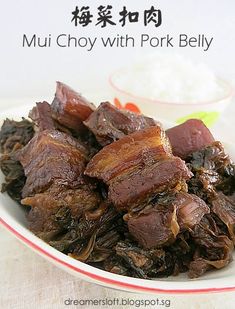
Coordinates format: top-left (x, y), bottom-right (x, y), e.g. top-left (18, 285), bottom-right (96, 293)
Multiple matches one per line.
top-left (51, 82), bottom-right (95, 133)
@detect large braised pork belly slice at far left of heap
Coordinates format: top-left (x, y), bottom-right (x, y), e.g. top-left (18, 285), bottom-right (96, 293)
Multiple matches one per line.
top-left (17, 130), bottom-right (101, 230)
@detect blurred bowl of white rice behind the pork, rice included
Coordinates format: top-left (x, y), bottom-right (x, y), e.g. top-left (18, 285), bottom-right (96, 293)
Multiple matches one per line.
top-left (109, 54), bottom-right (234, 126)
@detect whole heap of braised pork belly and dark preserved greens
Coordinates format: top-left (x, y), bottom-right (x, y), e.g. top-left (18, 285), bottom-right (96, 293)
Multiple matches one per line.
top-left (0, 82), bottom-right (235, 279)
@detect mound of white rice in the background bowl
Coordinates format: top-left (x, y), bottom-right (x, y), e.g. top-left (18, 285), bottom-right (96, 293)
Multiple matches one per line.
top-left (113, 54), bottom-right (225, 103)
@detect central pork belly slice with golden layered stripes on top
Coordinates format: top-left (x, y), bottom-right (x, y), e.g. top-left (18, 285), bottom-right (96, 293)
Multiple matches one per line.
top-left (85, 127), bottom-right (192, 210)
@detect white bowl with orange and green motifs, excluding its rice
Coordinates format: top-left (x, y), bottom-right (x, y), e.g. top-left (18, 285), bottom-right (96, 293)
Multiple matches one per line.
top-left (109, 69), bottom-right (234, 127)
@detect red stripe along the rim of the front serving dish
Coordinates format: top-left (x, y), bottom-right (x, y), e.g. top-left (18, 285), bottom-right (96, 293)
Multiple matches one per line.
top-left (0, 218), bottom-right (235, 294)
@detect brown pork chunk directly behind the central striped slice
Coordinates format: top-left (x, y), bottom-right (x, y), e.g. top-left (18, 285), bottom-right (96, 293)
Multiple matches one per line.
top-left (84, 102), bottom-right (159, 146)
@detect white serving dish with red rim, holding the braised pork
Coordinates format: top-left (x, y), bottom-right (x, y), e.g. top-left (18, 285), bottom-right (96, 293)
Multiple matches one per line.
top-left (0, 101), bottom-right (235, 294)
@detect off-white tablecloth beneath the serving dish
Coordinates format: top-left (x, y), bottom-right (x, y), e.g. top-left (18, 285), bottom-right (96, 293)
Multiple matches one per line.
top-left (0, 103), bottom-right (235, 309)
